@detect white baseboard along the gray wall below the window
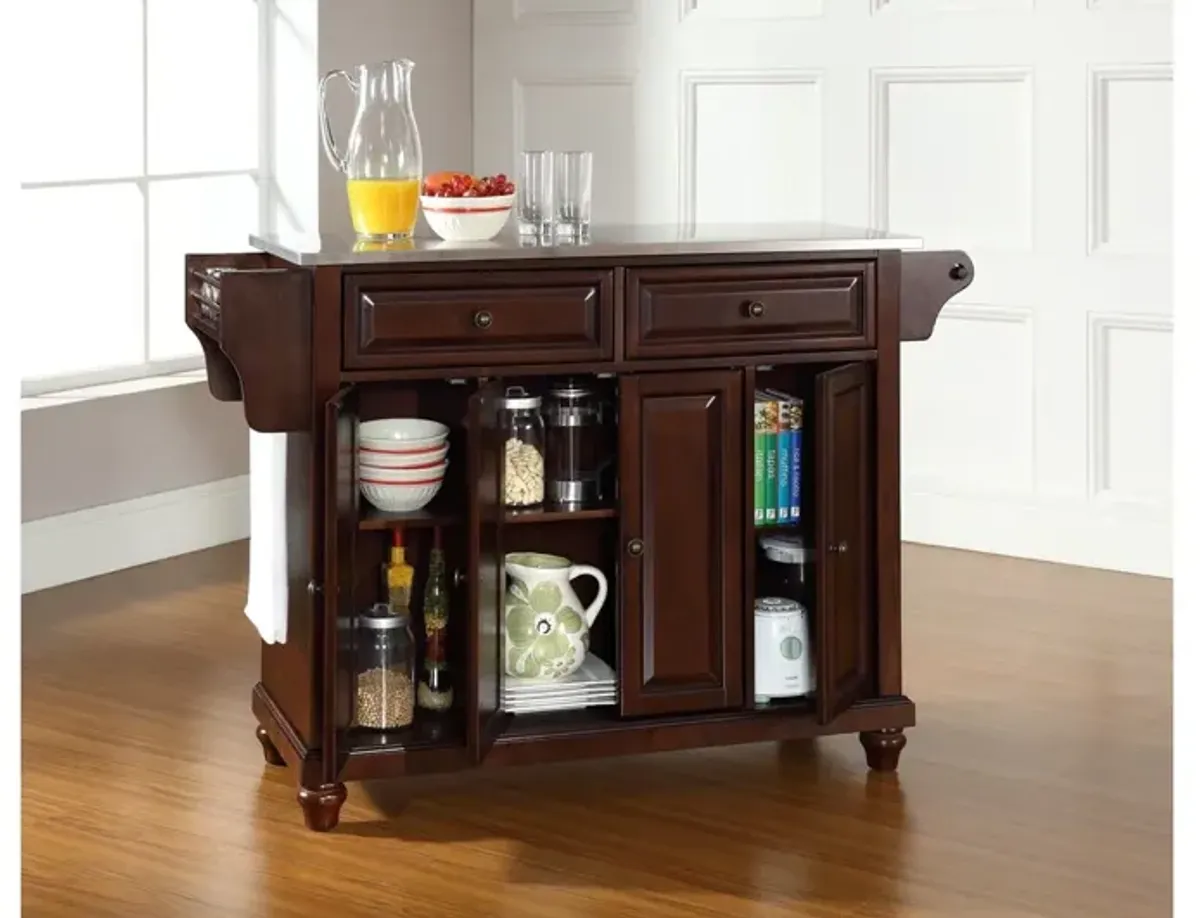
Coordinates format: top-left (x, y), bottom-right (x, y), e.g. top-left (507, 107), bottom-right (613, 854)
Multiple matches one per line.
top-left (20, 475), bottom-right (250, 594)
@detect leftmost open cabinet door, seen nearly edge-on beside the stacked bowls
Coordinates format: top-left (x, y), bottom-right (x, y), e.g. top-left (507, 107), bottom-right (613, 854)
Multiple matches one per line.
top-left (320, 386), bottom-right (359, 784)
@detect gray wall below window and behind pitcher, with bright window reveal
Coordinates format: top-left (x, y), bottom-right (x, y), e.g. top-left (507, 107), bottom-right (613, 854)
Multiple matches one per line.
top-left (22, 0), bottom-right (472, 521)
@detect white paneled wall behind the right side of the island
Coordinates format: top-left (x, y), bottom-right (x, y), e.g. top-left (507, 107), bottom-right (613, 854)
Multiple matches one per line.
top-left (473, 0), bottom-right (1171, 574)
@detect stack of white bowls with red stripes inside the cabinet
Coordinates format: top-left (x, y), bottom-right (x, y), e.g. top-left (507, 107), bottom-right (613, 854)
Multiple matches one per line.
top-left (358, 418), bottom-right (450, 514)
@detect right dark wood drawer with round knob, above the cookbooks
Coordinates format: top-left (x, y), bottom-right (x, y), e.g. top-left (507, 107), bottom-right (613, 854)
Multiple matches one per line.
top-left (625, 262), bottom-right (875, 360)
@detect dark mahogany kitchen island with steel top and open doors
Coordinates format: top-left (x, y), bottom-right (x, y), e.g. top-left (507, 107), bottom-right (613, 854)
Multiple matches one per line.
top-left (186, 224), bottom-right (973, 830)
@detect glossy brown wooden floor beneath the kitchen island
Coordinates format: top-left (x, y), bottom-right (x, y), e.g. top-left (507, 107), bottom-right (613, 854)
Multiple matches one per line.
top-left (23, 545), bottom-right (1171, 918)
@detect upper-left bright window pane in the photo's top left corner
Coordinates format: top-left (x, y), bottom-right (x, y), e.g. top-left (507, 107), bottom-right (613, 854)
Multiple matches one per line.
top-left (18, 0), bottom-right (141, 181)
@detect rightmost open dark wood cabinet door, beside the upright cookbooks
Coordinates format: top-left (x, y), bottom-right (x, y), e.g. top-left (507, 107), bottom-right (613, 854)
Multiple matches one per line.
top-left (816, 364), bottom-right (874, 722)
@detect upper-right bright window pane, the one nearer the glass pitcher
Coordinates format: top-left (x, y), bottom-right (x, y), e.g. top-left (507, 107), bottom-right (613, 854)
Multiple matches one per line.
top-left (146, 0), bottom-right (258, 174)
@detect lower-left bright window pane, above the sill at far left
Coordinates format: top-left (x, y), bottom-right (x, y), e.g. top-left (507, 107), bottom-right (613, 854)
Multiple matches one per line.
top-left (19, 184), bottom-right (145, 379)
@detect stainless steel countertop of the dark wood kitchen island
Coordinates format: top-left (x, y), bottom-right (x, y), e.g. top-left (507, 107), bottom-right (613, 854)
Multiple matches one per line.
top-left (250, 222), bottom-right (923, 265)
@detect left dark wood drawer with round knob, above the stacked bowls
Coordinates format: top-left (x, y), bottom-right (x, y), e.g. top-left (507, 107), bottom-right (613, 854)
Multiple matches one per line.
top-left (342, 271), bottom-right (613, 370)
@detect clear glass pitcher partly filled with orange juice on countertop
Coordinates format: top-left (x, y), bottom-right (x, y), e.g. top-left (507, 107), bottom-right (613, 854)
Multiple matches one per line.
top-left (320, 60), bottom-right (422, 241)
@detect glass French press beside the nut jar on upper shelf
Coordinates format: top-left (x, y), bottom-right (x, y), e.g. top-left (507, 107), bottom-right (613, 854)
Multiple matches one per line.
top-left (544, 379), bottom-right (605, 505)
